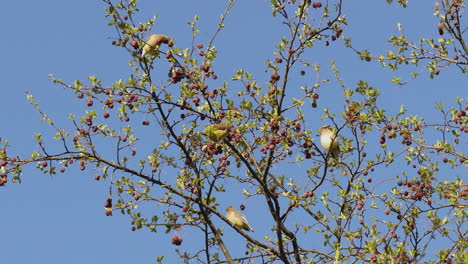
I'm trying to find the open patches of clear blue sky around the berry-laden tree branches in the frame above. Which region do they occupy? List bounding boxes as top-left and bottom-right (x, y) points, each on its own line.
(0, 0), (468, 264)
